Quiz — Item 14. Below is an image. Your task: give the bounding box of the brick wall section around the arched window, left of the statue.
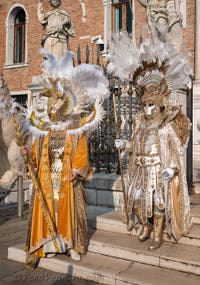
[0,0,42,91]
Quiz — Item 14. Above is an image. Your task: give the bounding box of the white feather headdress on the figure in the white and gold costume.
[107,33,192,101]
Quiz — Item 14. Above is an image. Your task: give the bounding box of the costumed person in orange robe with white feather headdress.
[21,49,109,268]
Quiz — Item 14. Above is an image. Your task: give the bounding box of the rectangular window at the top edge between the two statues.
[112,0,132,34]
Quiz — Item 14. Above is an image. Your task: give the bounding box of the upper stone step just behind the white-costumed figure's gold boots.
[92,206,200,247]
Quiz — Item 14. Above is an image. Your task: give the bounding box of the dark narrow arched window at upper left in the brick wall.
[14,9,26,63]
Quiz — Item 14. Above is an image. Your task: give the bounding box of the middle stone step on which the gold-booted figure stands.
[89,230,200,280]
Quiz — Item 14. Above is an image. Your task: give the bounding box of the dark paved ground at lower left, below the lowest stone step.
[0,207,100,285]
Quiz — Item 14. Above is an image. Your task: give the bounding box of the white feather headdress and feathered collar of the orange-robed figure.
[24,49,109,136]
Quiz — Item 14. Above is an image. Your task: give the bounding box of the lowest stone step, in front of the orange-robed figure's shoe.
[8,242,200,285]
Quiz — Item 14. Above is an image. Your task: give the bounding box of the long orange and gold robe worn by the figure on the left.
[24,130,91,262]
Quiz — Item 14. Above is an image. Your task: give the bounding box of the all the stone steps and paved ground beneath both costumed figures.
[0,195,200,285]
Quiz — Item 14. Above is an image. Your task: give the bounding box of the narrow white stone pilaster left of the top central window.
[103,0,112,51]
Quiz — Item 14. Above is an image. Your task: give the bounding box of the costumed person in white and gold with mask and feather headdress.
[108,35,191,250]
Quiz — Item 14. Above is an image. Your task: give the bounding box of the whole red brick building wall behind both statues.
[0,0,195,91]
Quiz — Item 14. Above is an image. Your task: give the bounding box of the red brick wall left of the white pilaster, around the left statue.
[0,0,103,91]
